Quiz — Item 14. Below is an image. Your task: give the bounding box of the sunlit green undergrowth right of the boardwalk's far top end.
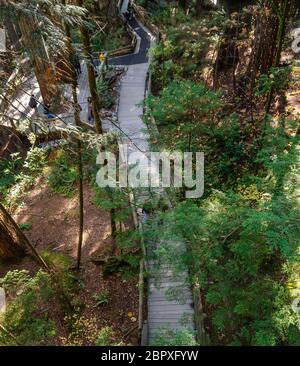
[151,5,223,94]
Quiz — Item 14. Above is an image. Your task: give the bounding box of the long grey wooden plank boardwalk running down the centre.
[113,6,195,345]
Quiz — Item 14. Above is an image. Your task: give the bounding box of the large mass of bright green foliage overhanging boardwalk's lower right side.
[148,129,300,346]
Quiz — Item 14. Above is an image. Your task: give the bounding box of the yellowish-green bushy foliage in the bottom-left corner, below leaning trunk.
[0,270,56,345]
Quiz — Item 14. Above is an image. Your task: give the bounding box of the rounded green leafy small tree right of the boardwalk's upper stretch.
[147,81,222,151]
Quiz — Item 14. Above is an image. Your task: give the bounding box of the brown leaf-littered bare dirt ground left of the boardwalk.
[0,178,138,345]
